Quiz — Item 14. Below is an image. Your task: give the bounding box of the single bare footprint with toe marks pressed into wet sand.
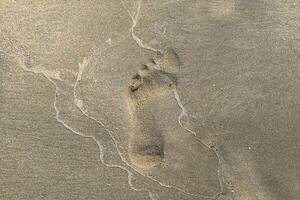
[127,49,180,170]
